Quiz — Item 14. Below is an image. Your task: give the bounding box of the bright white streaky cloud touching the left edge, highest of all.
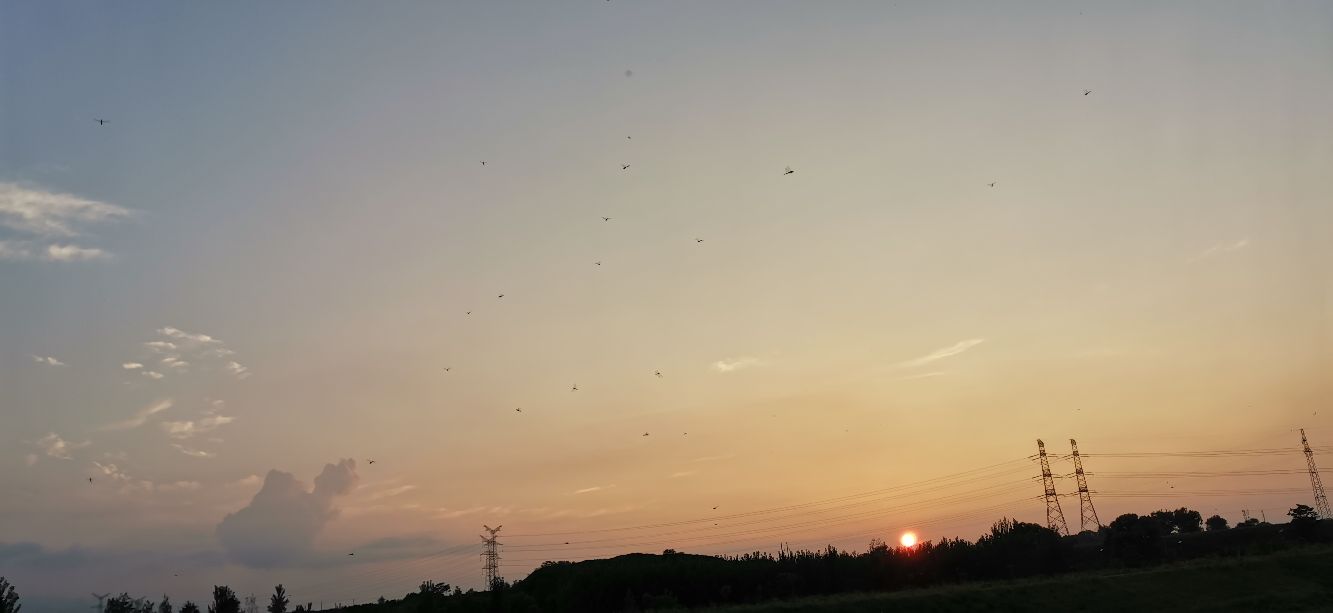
[0,183,129,261]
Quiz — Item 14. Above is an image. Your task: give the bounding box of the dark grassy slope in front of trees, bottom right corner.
[708,546,1333,613]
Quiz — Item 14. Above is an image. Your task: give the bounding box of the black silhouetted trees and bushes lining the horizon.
[10,505,1333,613]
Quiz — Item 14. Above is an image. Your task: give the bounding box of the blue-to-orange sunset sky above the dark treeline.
[0,0,1333,610]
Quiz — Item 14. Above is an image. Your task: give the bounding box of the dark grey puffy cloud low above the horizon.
[217,460,357,568]
